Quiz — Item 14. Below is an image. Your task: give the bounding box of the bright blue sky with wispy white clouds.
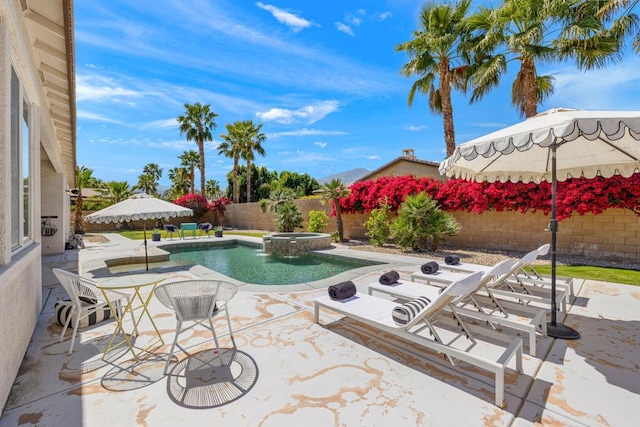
[75,0,640,188]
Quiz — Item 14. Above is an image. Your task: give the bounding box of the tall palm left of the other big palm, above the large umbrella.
[396,0,471,156]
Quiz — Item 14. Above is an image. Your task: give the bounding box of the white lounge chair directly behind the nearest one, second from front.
[368,259,548,356]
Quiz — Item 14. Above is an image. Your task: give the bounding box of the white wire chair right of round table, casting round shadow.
[154,280,238,375]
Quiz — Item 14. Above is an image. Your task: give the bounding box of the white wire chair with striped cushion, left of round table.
[51,268,136,354]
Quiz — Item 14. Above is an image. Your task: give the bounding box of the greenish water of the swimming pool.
[167,244,378,285]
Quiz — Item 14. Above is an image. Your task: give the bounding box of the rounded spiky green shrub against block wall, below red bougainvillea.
[391,193,460,251]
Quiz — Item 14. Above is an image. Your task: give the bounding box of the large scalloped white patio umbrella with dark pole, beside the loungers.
[439,108,640,339]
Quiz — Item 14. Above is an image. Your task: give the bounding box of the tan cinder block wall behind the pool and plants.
[85,199,640,262]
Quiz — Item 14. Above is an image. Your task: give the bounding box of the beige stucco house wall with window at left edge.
[0,0,68,411]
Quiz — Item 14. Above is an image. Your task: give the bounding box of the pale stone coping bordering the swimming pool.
[81,235,419,292]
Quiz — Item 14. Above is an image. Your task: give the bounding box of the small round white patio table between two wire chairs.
[98,273,165,360]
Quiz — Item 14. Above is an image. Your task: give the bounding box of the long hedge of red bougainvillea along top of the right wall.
[340,173,640,220]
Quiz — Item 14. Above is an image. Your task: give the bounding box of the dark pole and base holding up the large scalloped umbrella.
[547,144,580,340]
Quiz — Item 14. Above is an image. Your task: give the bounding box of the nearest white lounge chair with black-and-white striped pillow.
[314,272,522,407]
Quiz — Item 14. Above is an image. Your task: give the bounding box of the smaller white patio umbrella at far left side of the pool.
[84,193,193,270]
